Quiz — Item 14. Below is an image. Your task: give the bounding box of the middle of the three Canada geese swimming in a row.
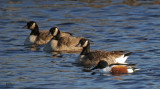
[43,27,83,52]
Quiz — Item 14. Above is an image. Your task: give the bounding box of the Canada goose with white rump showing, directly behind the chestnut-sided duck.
[76,38,131,67]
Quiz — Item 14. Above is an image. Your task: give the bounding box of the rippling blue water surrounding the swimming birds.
[0,0,160,89]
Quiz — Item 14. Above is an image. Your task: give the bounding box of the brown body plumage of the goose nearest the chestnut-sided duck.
[82,51,124,67]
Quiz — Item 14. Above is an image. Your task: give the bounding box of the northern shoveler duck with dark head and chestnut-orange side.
[91,60,140,75]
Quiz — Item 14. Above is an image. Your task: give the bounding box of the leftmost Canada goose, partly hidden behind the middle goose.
[23,21,71,45]
